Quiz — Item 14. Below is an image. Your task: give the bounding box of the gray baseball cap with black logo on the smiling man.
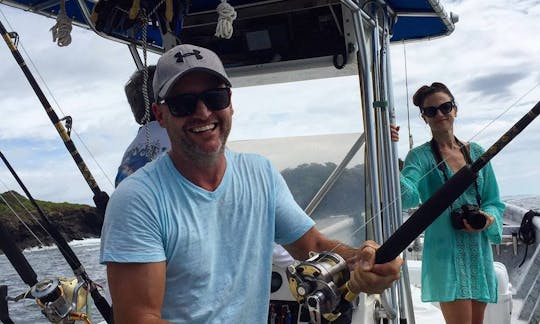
[152,44,231,101]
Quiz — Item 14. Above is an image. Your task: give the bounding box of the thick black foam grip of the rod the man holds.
[375,165,478,264]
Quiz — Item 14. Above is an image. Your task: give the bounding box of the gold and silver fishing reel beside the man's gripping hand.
[286,252,357,323]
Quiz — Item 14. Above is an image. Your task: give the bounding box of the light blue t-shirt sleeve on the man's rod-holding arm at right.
[272,168,315,245]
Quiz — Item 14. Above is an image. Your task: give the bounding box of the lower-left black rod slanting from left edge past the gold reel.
[0,151,113,323]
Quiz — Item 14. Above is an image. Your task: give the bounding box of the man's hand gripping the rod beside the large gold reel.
[349,241,403,294]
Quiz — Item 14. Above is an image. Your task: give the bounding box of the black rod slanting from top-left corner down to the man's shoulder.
[0,20,109,214]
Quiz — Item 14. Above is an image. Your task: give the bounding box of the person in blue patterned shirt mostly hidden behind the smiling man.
[114,65,171,187]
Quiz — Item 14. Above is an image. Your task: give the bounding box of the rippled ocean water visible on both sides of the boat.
[0,196,540,324]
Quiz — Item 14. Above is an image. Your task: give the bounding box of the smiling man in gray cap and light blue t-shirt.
[101,44,402,324]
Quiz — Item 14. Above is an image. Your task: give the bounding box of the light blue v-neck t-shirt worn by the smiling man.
[101,150,314,323]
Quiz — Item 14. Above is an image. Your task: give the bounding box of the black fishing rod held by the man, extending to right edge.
[375,101,540,264]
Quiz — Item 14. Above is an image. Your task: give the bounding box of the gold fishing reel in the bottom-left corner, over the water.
[30,278,90,324]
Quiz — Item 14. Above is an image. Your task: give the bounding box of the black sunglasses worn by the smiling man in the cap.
[159,88,231,117]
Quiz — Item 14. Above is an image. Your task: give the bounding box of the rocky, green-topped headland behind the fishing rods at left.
[0,191,103,253]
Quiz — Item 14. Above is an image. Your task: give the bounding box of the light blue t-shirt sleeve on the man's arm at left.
[100,177,166,263]
